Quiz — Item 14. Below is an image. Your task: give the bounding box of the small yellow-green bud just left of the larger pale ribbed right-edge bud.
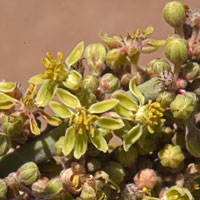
[156,91,175,108]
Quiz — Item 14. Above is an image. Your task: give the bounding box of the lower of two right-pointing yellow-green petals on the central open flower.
[97,117,124,130]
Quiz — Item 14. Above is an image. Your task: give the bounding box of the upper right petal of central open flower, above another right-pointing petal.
[89,99,119,113]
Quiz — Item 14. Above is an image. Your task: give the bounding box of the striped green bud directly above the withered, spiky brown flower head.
[147,58,171,76]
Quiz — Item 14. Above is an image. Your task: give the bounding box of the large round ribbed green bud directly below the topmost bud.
[165,37,189,64]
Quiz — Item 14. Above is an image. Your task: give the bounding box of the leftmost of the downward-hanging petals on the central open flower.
[62,127,76,156]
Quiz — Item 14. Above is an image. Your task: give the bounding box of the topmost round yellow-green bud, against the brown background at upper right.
[163,1,185,27]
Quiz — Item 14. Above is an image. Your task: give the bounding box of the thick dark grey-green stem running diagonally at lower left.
[0,122,68,178]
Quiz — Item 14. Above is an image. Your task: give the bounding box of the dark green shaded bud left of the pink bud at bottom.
[103,161,125,184]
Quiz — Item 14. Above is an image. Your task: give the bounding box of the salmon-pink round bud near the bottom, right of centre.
[134,169,158,190]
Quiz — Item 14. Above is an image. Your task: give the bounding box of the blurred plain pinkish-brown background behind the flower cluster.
[0,0,200,87]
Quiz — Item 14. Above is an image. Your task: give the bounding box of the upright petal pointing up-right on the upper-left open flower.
[65,42,84,69]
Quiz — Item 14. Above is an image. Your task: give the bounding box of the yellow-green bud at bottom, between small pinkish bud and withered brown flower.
[44,178,63,194]
